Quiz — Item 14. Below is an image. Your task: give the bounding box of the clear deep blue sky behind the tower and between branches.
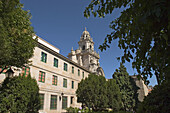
[21,0,156,85]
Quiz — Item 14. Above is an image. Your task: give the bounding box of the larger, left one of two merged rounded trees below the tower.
[76,74,108,111]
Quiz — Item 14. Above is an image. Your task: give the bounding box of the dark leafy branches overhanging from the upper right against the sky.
[84,0,170,84]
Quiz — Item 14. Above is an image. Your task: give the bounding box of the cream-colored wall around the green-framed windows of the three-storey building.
[30,47,89,113]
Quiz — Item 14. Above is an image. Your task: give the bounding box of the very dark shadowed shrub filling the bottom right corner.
[137,80,170,113]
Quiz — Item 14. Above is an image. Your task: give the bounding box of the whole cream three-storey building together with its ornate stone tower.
[0,29,105,113]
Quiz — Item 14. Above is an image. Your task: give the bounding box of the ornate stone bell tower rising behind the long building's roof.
[68,28,105,76]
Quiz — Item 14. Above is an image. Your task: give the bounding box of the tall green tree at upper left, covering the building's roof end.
[0,0,36,73]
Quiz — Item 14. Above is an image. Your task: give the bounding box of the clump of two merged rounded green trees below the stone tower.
[76,74,121,111]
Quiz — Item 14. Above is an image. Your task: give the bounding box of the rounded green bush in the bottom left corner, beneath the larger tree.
[0,75,40,113]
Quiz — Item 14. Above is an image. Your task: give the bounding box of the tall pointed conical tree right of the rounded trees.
[113,63,138,111]
